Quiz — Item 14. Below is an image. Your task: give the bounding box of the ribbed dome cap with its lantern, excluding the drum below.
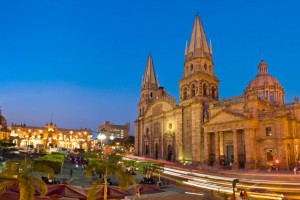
[246,60,282,92]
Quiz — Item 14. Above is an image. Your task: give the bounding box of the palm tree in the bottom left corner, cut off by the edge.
[0,158,54,200]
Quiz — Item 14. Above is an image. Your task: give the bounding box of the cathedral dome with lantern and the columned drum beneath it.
[245,60,284,104]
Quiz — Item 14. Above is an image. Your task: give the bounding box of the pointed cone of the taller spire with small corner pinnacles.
[185,15,212,58]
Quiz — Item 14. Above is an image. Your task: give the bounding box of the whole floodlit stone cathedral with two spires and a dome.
[135,16,300,169]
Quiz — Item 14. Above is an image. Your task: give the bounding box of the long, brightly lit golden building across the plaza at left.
[10,122,92,150]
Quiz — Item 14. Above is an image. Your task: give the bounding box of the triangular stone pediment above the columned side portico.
[203,110,249,126]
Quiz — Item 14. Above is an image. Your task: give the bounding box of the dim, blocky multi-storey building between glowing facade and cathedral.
[98,121,130,139]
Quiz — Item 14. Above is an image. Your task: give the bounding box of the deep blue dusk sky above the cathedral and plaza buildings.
[0,0,300,133]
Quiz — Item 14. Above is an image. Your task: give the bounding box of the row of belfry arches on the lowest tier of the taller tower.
[181,83,218,100]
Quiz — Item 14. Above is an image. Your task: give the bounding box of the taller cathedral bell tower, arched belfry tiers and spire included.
[179,15,220,105]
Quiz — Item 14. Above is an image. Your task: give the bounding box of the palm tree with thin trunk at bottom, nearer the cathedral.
[87,153,135,200]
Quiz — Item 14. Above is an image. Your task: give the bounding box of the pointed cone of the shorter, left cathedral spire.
[142,54,158,89]
